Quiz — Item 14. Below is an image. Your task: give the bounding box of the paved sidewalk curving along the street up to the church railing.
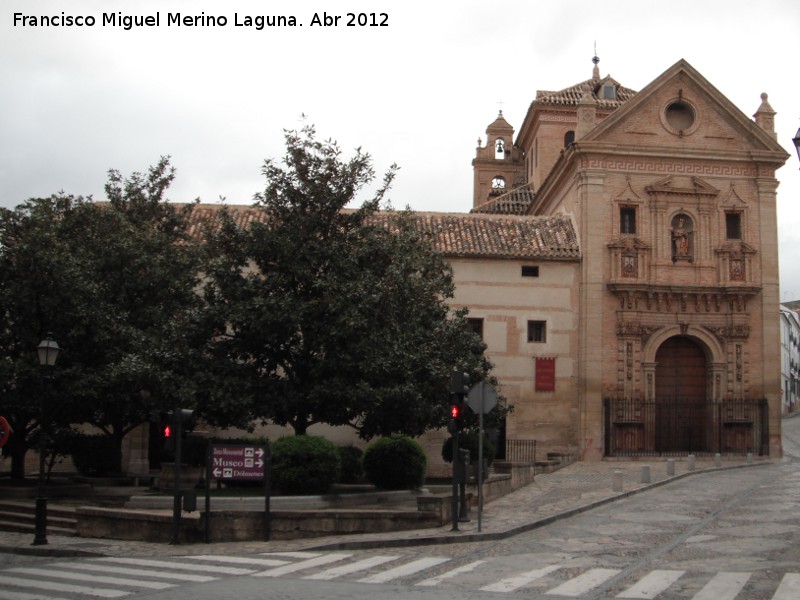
[0,458,772,557]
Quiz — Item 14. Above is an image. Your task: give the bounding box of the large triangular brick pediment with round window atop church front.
[581,60,788,160]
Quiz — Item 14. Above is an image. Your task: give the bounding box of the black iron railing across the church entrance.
[603,398,769,457]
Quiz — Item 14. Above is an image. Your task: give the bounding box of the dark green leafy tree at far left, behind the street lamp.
[0,158,201,478]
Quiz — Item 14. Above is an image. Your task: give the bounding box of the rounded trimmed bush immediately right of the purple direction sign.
[272,435,341,494]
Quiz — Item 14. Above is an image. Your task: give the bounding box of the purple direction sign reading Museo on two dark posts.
[205,444,271,543]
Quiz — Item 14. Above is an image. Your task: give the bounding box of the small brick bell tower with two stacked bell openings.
[472,110,524,208]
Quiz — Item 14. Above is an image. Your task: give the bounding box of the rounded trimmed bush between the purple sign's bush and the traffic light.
[362,437,428,490]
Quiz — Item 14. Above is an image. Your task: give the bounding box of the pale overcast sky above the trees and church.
[0,0,800,301]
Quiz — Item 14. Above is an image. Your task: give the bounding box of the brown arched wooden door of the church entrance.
[655,336,711,453]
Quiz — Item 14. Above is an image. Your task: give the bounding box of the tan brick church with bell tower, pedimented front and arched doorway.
[468,58,788,460]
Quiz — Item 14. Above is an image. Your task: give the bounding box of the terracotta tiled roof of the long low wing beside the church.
[182,204,580,260]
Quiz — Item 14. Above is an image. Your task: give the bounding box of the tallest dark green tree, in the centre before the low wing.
[197,127,490,439]
